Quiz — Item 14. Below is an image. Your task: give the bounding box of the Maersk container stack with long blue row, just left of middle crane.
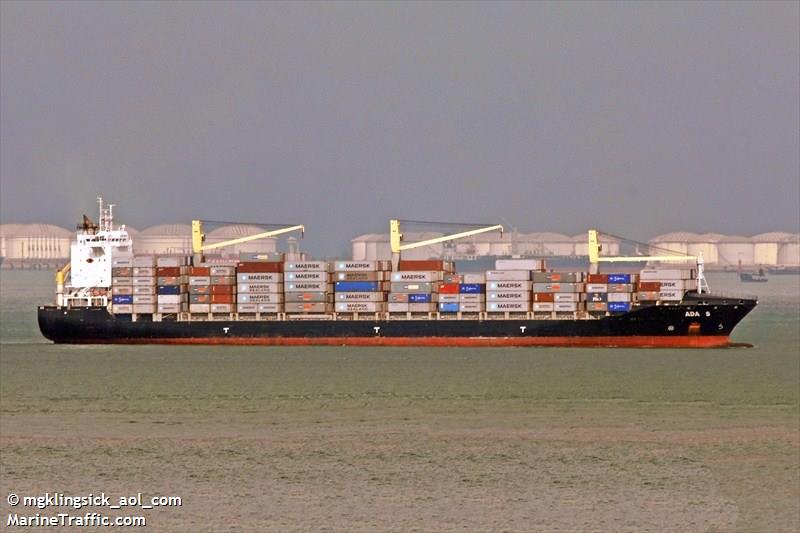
[333,261,391,316]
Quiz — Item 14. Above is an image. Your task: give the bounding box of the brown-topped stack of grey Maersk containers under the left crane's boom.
[236,261,284,316]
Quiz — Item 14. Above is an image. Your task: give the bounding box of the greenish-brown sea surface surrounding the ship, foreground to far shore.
[0,271,800,531]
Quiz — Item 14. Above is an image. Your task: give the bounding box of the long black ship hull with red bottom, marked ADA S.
[38,294,757,347]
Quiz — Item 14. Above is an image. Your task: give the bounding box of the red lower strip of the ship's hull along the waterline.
[67,335,731,348]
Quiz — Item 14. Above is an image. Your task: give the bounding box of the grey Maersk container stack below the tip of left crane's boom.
[283,261,333,314]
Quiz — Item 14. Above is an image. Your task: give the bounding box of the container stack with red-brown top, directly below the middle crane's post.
[387,260,450,313]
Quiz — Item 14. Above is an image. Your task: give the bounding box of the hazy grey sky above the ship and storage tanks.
[0,1,800,254]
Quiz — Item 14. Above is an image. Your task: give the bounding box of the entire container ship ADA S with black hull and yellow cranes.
[38,199,757,347]
